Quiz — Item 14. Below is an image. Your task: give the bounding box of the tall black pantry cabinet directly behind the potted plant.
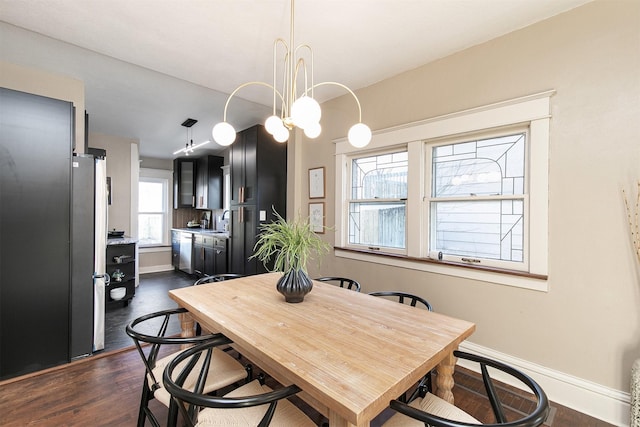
[229,125,287,275]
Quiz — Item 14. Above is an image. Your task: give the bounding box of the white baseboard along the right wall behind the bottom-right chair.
[458,341,631,427]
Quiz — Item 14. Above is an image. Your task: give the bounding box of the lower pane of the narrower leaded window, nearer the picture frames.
[349,202,405,249]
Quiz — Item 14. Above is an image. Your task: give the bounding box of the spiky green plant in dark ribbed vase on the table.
[251,209,330,303]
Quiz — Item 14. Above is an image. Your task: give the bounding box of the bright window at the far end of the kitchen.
[138,169,171,246]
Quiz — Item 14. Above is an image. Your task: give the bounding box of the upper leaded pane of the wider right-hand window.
[432,133,525,197]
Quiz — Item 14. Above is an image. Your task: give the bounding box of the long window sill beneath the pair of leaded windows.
[334,247,549,292]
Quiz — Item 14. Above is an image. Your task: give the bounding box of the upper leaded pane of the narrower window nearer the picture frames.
[351,151,408,199]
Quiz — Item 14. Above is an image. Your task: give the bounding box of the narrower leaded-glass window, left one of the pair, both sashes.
[349,151,408,251]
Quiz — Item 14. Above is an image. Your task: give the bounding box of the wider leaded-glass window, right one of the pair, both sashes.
[425,129,527,270]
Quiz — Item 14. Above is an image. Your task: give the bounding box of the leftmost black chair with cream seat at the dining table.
[126,308,252,427]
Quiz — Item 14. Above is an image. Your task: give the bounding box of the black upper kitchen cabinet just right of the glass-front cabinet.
[195,156,224,209]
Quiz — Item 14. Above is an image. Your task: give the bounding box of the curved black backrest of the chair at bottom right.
[390,351,549,427]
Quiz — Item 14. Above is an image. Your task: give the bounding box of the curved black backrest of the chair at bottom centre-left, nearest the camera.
[162,335,300,426]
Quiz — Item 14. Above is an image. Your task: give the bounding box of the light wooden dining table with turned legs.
[169,273,475,427]
